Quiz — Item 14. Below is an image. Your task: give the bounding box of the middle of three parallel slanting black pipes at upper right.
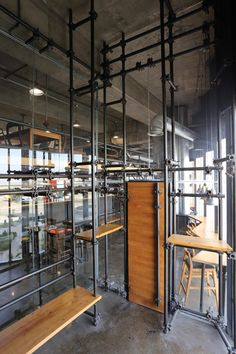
[106,22,214,66]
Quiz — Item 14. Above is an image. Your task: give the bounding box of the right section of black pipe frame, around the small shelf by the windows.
[160,0,236,354]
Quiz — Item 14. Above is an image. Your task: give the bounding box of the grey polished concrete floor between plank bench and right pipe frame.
[37,292,227,354]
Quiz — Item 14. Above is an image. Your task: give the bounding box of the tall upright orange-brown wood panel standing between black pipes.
[127,182,164,312]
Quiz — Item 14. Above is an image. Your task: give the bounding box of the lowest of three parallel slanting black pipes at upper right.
[109,42,214,79]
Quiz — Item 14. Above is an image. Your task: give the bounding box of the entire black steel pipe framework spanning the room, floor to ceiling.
[0,0,236,353]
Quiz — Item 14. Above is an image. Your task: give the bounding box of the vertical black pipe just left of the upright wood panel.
[121,32,128,294]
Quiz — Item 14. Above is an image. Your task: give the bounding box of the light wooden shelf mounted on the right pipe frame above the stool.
[168,234,233,253]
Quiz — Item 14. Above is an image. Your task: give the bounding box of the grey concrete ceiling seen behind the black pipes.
[0,0,213,137]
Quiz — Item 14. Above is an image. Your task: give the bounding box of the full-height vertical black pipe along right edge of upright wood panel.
[160,0,169,332]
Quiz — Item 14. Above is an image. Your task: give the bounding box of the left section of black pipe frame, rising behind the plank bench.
[0,0,98,324]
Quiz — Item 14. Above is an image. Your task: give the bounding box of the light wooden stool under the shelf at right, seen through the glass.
[179,248,218,306]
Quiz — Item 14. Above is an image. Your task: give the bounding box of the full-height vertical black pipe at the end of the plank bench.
[90,0,97,302]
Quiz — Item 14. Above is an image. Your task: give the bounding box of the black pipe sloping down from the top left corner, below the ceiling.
[0,5,90,70]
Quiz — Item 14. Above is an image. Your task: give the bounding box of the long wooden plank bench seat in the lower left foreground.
[0,287,101,354]
